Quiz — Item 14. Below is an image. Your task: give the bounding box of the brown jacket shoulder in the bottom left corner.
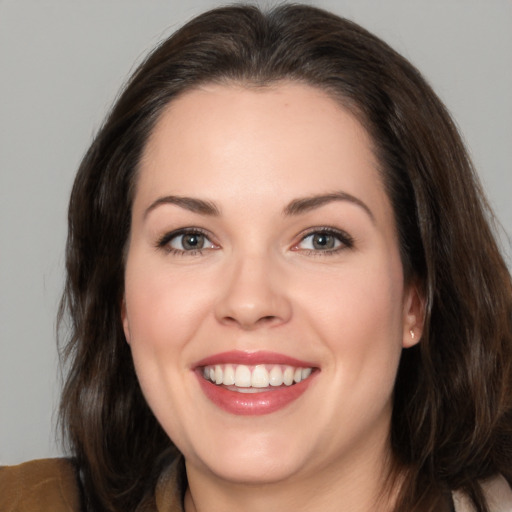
[0,459,79,512]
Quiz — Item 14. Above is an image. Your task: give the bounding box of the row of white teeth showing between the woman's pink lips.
[202,364,313,393]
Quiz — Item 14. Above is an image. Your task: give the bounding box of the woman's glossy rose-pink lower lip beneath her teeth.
[196,372,316,416]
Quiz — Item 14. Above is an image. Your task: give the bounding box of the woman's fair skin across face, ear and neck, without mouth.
[122,82,422,512]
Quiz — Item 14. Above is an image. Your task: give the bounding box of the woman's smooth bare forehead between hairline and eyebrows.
[136,82,385,220]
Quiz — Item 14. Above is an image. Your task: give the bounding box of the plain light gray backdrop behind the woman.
[0,0,512,464]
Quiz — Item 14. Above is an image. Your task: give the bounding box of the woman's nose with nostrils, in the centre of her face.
[215,256,292,331]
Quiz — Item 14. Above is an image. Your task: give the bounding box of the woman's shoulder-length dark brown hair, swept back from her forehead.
[60,5,512,512]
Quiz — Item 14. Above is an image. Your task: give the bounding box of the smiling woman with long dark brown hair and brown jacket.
[0,6,512,512]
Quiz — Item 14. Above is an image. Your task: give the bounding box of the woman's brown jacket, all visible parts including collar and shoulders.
[0,459,512,512]
